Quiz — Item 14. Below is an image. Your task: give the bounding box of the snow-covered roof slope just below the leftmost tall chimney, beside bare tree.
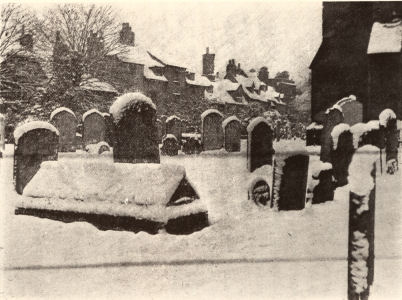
[109,44,163,67]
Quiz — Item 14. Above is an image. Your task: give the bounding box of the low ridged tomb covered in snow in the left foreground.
[16,161,208,234]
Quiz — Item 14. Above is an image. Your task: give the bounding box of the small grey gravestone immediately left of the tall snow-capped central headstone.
[82,109,106,147]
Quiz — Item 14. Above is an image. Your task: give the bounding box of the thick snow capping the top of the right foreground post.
[348,145,380,196]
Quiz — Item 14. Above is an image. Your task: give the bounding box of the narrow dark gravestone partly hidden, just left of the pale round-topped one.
[320,104,343,162]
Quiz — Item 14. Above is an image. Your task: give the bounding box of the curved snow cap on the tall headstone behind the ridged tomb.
[109,92,156,122]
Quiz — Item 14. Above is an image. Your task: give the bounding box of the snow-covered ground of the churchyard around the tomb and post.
[0,139,402,299]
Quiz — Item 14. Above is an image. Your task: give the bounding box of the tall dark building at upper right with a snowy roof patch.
[310,2,402,122]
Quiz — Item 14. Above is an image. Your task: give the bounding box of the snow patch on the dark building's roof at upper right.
[367,20,402,54]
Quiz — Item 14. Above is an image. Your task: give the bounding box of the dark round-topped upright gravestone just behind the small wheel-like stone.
[247,117,274,172]
